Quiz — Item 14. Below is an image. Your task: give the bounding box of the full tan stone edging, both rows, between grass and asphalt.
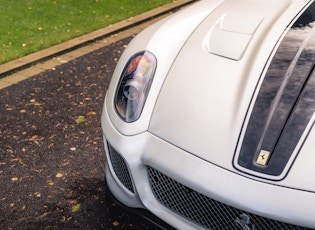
[0,0,195,90]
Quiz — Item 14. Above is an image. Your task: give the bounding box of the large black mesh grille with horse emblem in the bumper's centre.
[148,167,307,230]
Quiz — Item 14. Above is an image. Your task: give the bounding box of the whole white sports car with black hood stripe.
[102,0,315,230]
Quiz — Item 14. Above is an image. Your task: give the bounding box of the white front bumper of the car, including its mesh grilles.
[102,105,315,229]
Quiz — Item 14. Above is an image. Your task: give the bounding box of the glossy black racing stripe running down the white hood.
[237,0,315,179]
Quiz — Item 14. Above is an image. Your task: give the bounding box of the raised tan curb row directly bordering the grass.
[0,0,196,79]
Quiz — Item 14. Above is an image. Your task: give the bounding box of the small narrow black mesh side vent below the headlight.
[108,144,134,193]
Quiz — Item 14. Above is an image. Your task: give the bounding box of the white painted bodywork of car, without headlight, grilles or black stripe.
[102,0,315,229]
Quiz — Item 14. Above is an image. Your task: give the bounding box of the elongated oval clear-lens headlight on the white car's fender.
[114,51,157,122]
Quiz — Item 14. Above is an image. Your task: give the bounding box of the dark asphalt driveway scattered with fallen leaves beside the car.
[0,38,163,229]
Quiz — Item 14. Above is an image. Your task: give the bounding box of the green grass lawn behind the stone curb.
[0,0,172,64]
